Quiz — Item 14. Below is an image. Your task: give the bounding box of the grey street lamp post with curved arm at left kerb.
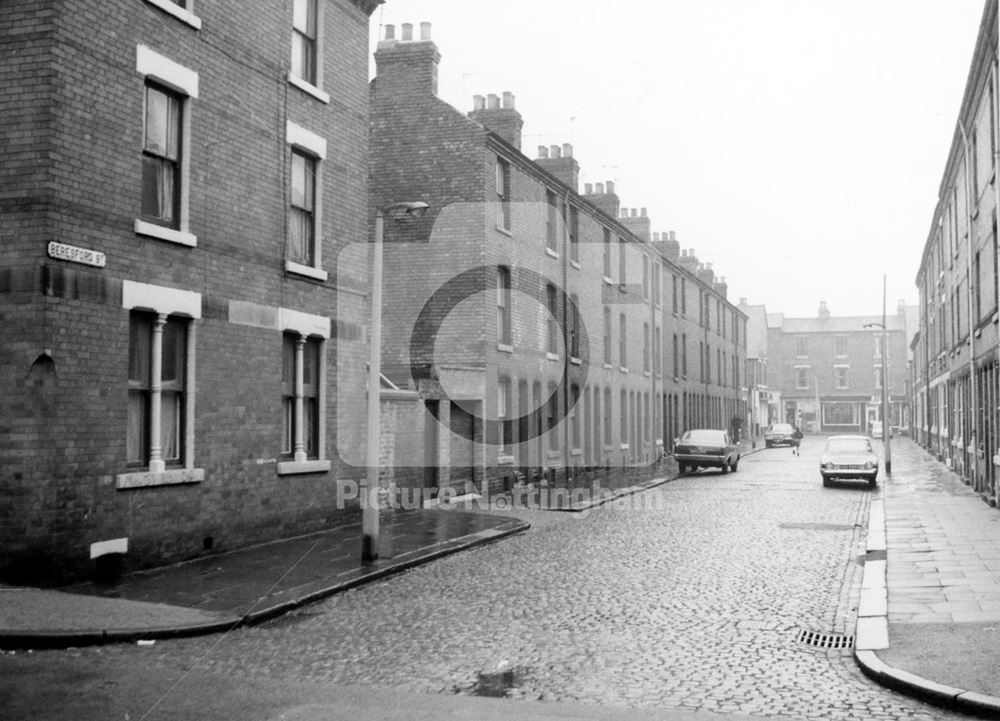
[361,201,428,561]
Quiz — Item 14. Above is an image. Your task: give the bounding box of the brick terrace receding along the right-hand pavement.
[912,0,1000,505]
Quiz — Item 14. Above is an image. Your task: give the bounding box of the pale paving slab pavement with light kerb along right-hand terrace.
[856,438,1000,718]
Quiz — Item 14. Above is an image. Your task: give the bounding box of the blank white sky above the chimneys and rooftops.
[371,0,983,316]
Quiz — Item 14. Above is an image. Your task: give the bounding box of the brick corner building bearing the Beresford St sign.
[0,0,377,581]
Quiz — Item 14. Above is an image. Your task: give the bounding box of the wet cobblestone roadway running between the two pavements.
[74,439,959,719]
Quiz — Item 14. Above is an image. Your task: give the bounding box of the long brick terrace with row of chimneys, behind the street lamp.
[371,23,746,492]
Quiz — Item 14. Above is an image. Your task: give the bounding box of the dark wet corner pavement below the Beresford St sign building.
[0,508,528,648]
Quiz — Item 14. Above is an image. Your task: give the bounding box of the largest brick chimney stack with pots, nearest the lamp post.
[375,22,441,100]
